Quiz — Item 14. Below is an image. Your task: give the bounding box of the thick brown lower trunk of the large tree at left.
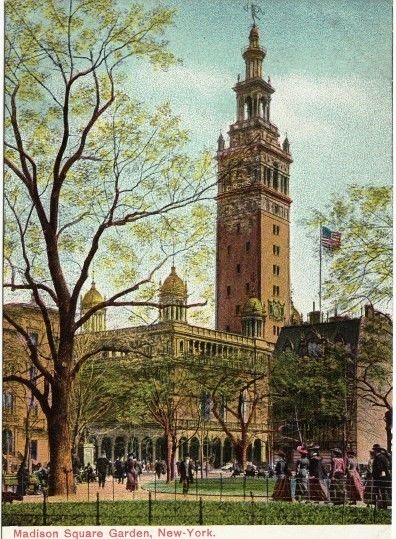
[47,374,75,495]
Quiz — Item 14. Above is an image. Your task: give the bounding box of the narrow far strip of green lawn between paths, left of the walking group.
[143,477,275,498]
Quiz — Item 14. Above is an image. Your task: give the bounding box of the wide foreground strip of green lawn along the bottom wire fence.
[2,500,391,526]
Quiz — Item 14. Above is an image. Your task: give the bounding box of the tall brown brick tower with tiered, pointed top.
[216,25,292,343]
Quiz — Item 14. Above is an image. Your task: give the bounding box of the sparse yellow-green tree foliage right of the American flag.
[307,185,392,309]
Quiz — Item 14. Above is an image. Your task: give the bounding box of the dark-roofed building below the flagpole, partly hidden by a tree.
[271,309,387,463]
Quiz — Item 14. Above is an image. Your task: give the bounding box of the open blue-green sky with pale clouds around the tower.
[130,0,392,320]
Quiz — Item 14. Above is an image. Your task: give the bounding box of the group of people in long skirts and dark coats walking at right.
[273,444,391,508]
